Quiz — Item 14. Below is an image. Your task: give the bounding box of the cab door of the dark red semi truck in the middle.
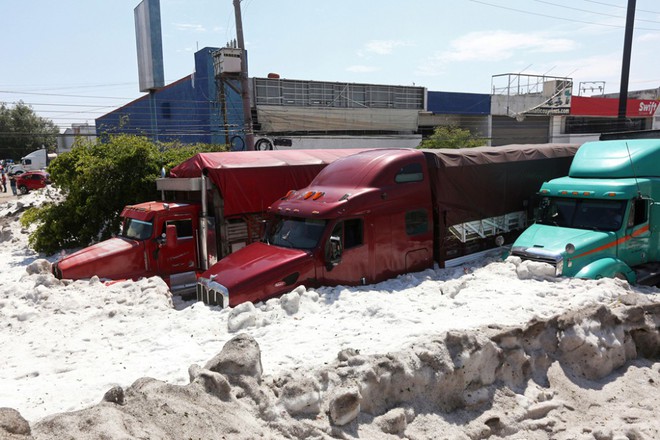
[321,218,373,286]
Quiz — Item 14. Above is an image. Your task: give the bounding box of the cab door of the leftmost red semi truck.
[156,217,197,278]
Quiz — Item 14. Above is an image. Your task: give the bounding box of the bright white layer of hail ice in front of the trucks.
[0,191,658,438]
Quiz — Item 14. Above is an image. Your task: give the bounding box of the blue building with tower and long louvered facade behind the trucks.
[96,47,491,150]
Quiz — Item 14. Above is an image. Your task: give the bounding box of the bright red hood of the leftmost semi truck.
[53,238,148,280]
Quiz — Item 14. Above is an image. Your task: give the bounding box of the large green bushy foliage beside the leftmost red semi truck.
[30,135,225,253]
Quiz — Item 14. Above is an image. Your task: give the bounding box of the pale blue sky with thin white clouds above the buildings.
[0,0,660,128]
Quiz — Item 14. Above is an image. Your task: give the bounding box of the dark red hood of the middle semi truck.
[200,243,316,306]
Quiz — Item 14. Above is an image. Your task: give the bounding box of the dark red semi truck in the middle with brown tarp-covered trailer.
[197,144,578,307]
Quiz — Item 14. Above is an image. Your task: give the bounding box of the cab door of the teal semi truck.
[619,198,651,267]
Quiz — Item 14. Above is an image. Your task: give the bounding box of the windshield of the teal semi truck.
[537,197,626,231]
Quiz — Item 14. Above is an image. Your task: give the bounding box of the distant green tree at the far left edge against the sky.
[0,101,59,161]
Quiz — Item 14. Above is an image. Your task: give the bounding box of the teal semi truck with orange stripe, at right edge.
[511,139,660,285]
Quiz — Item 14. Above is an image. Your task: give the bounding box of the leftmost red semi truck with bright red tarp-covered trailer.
[52,149,362,295]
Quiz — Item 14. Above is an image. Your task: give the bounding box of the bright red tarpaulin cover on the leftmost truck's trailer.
[170,149,364,217]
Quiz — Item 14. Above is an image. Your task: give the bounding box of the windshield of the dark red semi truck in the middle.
[265,217,326,249]
